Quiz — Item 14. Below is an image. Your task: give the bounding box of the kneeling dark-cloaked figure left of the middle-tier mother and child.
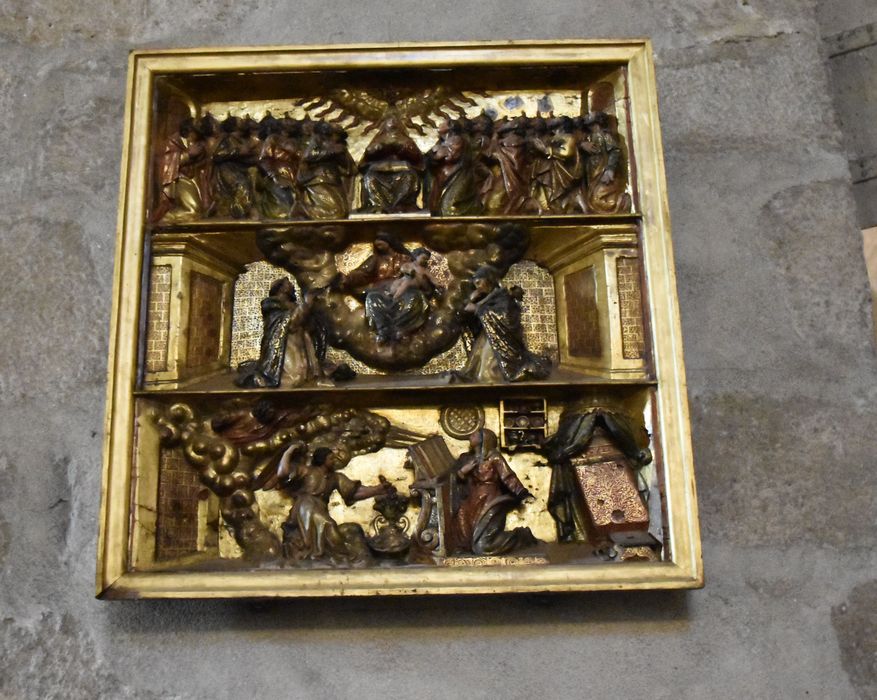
[235,277,323,388]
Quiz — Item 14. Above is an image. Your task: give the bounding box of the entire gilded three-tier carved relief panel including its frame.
[98,41,702,597]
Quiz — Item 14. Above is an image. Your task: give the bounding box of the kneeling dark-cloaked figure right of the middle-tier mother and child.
[451,265,551,382]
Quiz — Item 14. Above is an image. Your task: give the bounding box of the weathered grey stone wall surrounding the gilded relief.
[0,0,877,700]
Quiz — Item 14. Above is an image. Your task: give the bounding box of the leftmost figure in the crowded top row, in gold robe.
[151,119,207,223]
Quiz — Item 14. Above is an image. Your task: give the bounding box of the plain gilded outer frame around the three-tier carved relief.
[97,39,703,598]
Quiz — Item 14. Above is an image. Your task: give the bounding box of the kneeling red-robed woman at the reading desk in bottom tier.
[450,428,538,556]
